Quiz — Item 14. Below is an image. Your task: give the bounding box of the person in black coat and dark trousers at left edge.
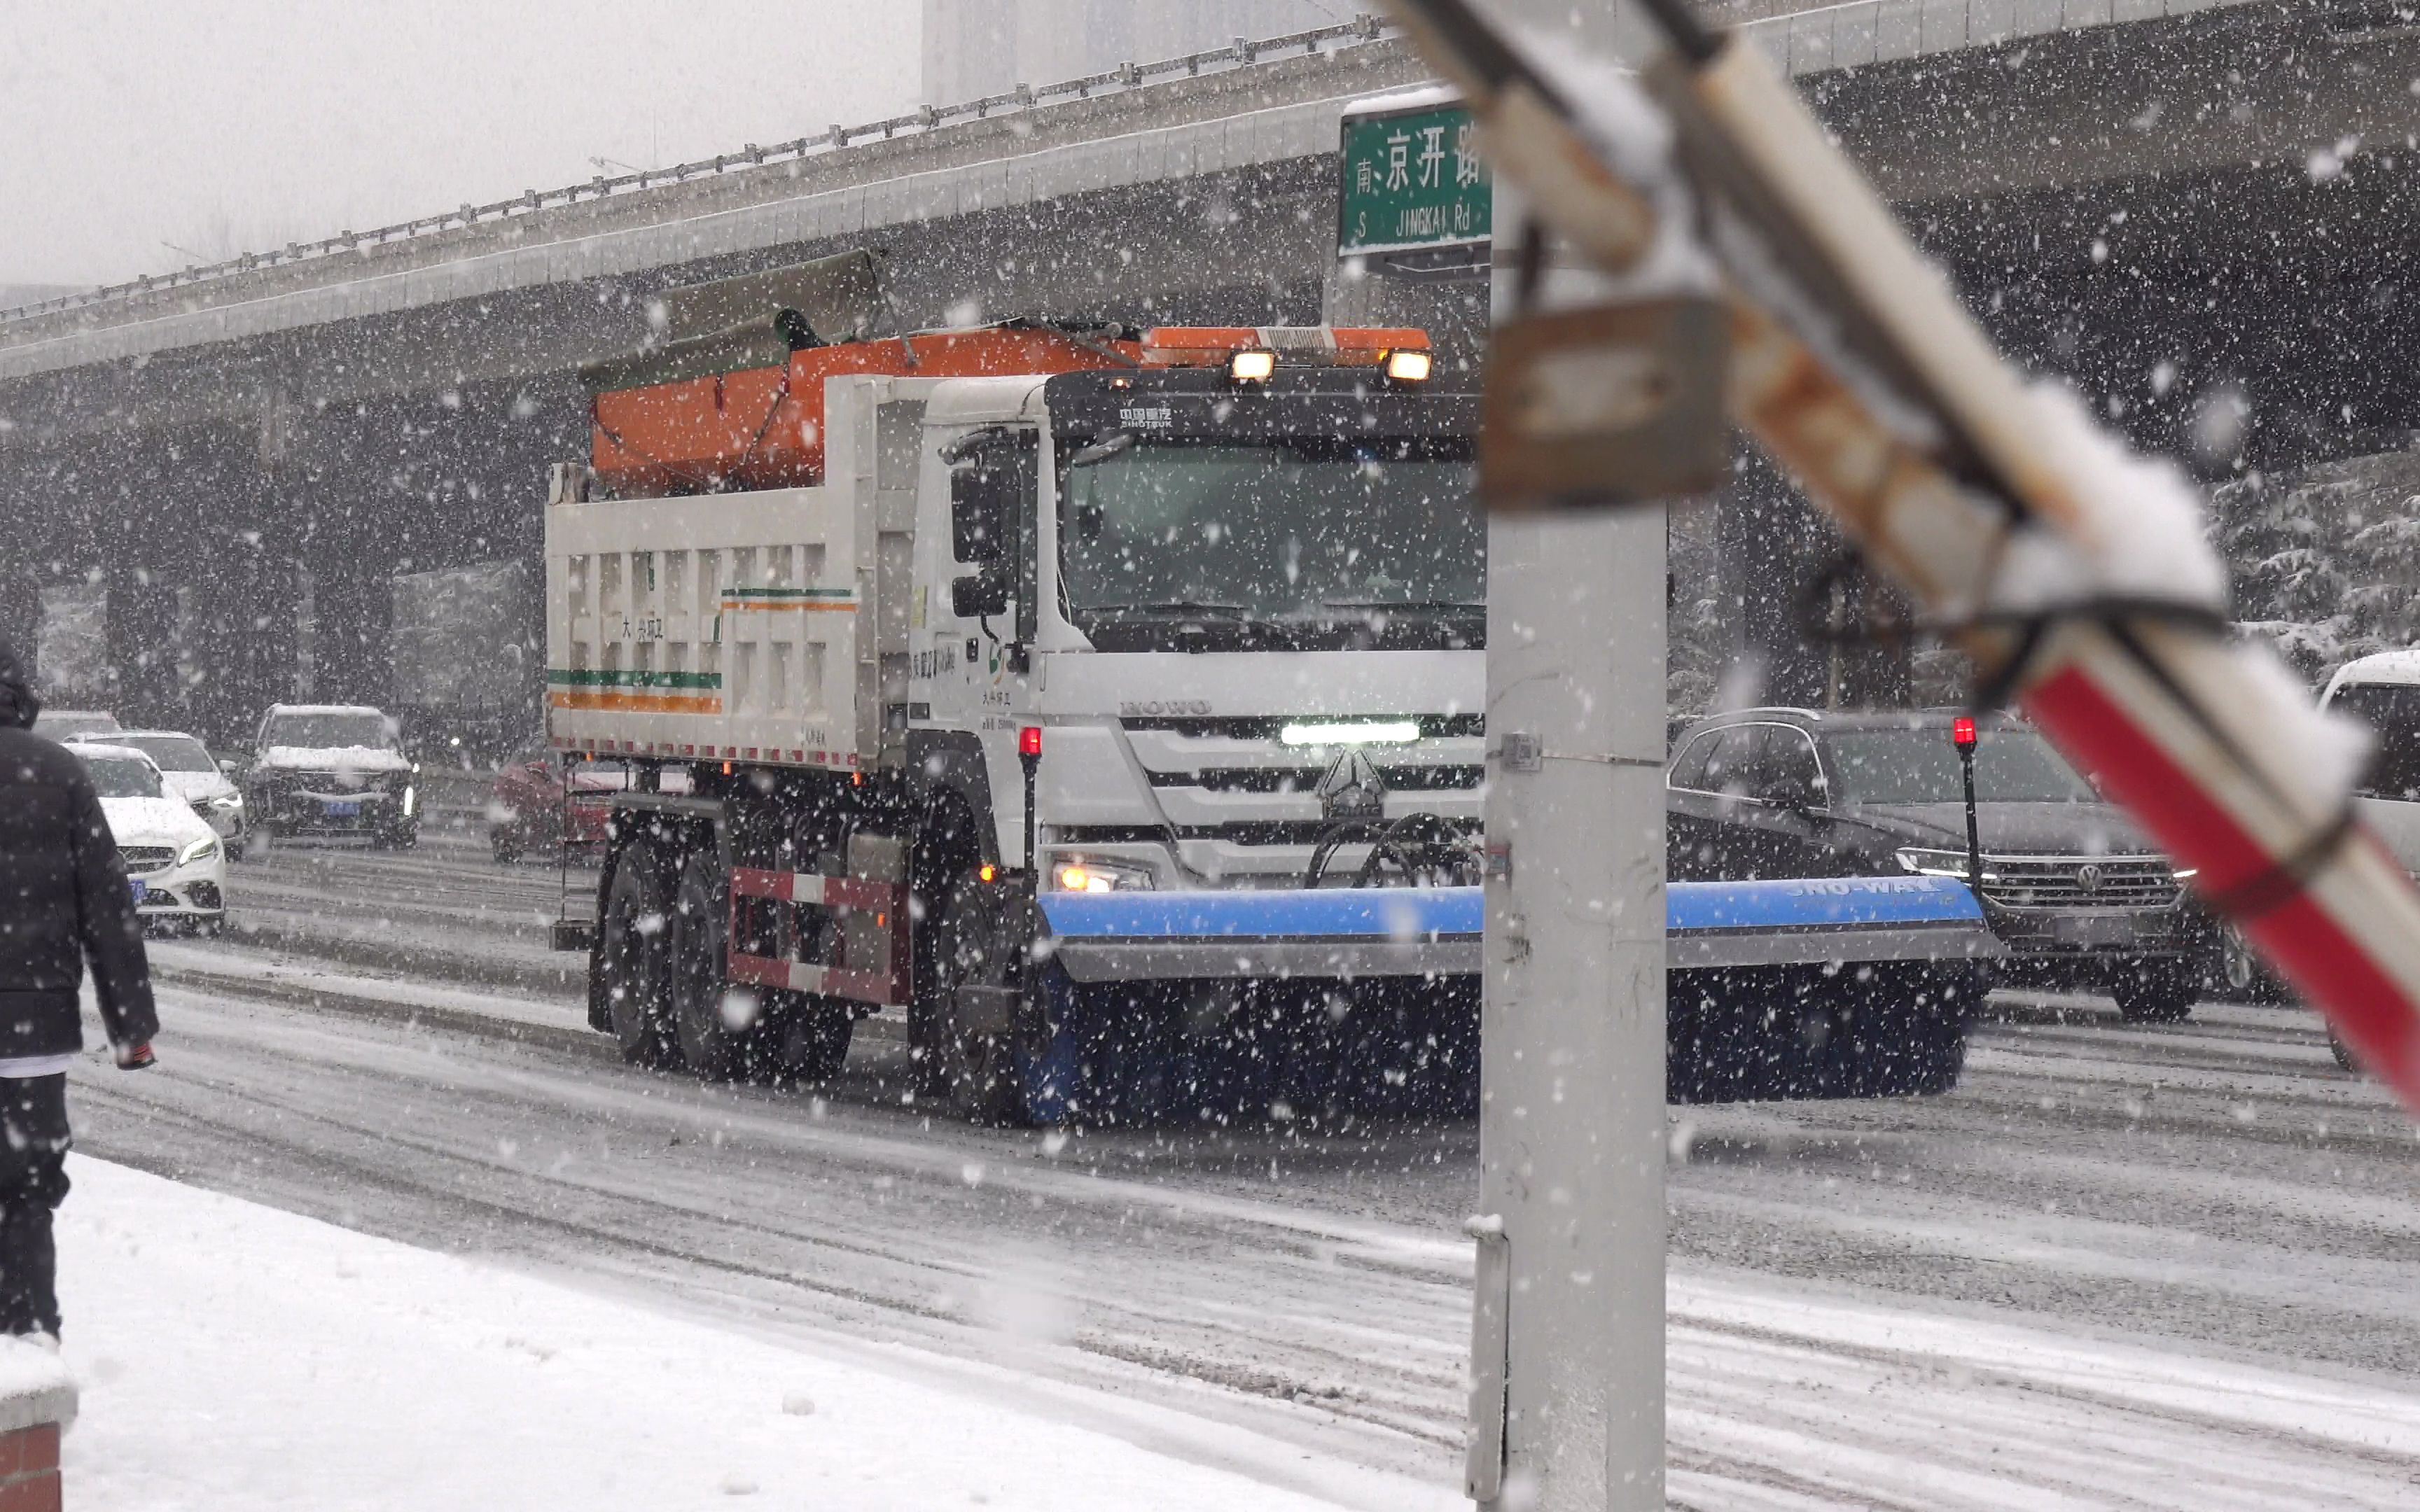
[0,641,160,1338]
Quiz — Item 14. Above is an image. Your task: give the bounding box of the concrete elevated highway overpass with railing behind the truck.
[0,0,2420,728]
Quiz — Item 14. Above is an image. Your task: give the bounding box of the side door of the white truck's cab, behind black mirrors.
[912,426,1041,856]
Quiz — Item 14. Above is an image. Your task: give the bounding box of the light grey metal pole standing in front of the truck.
[1466,164,1665,1512]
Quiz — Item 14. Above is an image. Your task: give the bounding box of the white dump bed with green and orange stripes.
[545,377,934,769]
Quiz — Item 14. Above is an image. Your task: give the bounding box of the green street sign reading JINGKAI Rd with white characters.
[1336,104,1496,256]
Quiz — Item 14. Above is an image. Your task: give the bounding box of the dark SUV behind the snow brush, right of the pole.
[1665,709,2202,1023]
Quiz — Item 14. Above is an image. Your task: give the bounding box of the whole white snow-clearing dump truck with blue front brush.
[545,256,1996,1123]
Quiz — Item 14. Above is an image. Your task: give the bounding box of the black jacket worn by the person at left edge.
[0,643,160,1057]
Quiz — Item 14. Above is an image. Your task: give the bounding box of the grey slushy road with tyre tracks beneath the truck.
[70,832,2420,1507]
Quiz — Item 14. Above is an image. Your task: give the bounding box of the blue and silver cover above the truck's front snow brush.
[1041,876,2001,982]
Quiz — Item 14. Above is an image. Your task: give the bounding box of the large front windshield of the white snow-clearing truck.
[1060,438,1486,641]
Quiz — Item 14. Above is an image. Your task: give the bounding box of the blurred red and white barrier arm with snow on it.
[1386,0,2420,1113]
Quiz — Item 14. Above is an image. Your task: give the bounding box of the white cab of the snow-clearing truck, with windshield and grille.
[908,348,1486,892]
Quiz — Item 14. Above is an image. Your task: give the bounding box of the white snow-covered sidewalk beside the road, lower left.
[58,1156,1461,1512]
